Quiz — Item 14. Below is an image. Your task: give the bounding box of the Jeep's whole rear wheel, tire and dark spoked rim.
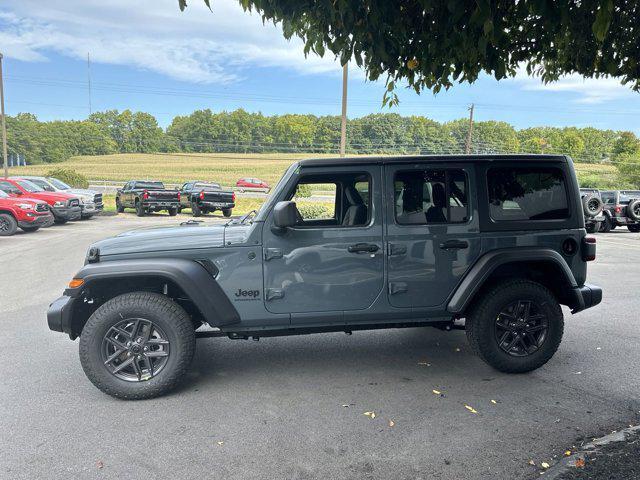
[465,280,564,373]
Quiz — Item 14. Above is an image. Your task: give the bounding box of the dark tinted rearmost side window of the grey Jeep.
[487,167,569,221]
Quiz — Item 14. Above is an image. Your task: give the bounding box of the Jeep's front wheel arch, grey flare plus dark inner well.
[63,259,240,338]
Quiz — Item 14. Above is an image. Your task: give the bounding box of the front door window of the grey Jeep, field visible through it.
[289,173,371,227]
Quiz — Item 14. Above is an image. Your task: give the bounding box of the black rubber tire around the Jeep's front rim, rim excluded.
[79,292,196,400]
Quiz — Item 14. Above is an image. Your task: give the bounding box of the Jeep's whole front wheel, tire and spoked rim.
[80,292,195,400]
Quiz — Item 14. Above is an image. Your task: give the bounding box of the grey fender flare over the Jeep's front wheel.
[70,258,240,327]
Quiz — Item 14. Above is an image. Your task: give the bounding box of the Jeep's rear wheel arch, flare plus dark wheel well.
[447,248,582,316]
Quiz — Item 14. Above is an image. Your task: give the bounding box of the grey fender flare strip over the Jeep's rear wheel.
[447,248,581,314]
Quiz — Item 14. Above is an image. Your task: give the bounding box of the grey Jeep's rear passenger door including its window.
[385,162,481,309]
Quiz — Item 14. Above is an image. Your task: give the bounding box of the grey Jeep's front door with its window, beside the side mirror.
[263,165,384,324]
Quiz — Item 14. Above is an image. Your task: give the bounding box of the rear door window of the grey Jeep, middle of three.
[393,169,469,225]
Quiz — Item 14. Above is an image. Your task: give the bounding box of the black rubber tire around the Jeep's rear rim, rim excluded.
[465,279,564,373]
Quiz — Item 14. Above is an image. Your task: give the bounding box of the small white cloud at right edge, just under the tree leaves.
[515,72,638,104]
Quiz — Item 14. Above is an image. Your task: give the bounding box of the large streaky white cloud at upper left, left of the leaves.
[0,0,340,83]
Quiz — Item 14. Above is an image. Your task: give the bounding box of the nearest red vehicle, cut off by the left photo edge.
[0,190,53,237]
